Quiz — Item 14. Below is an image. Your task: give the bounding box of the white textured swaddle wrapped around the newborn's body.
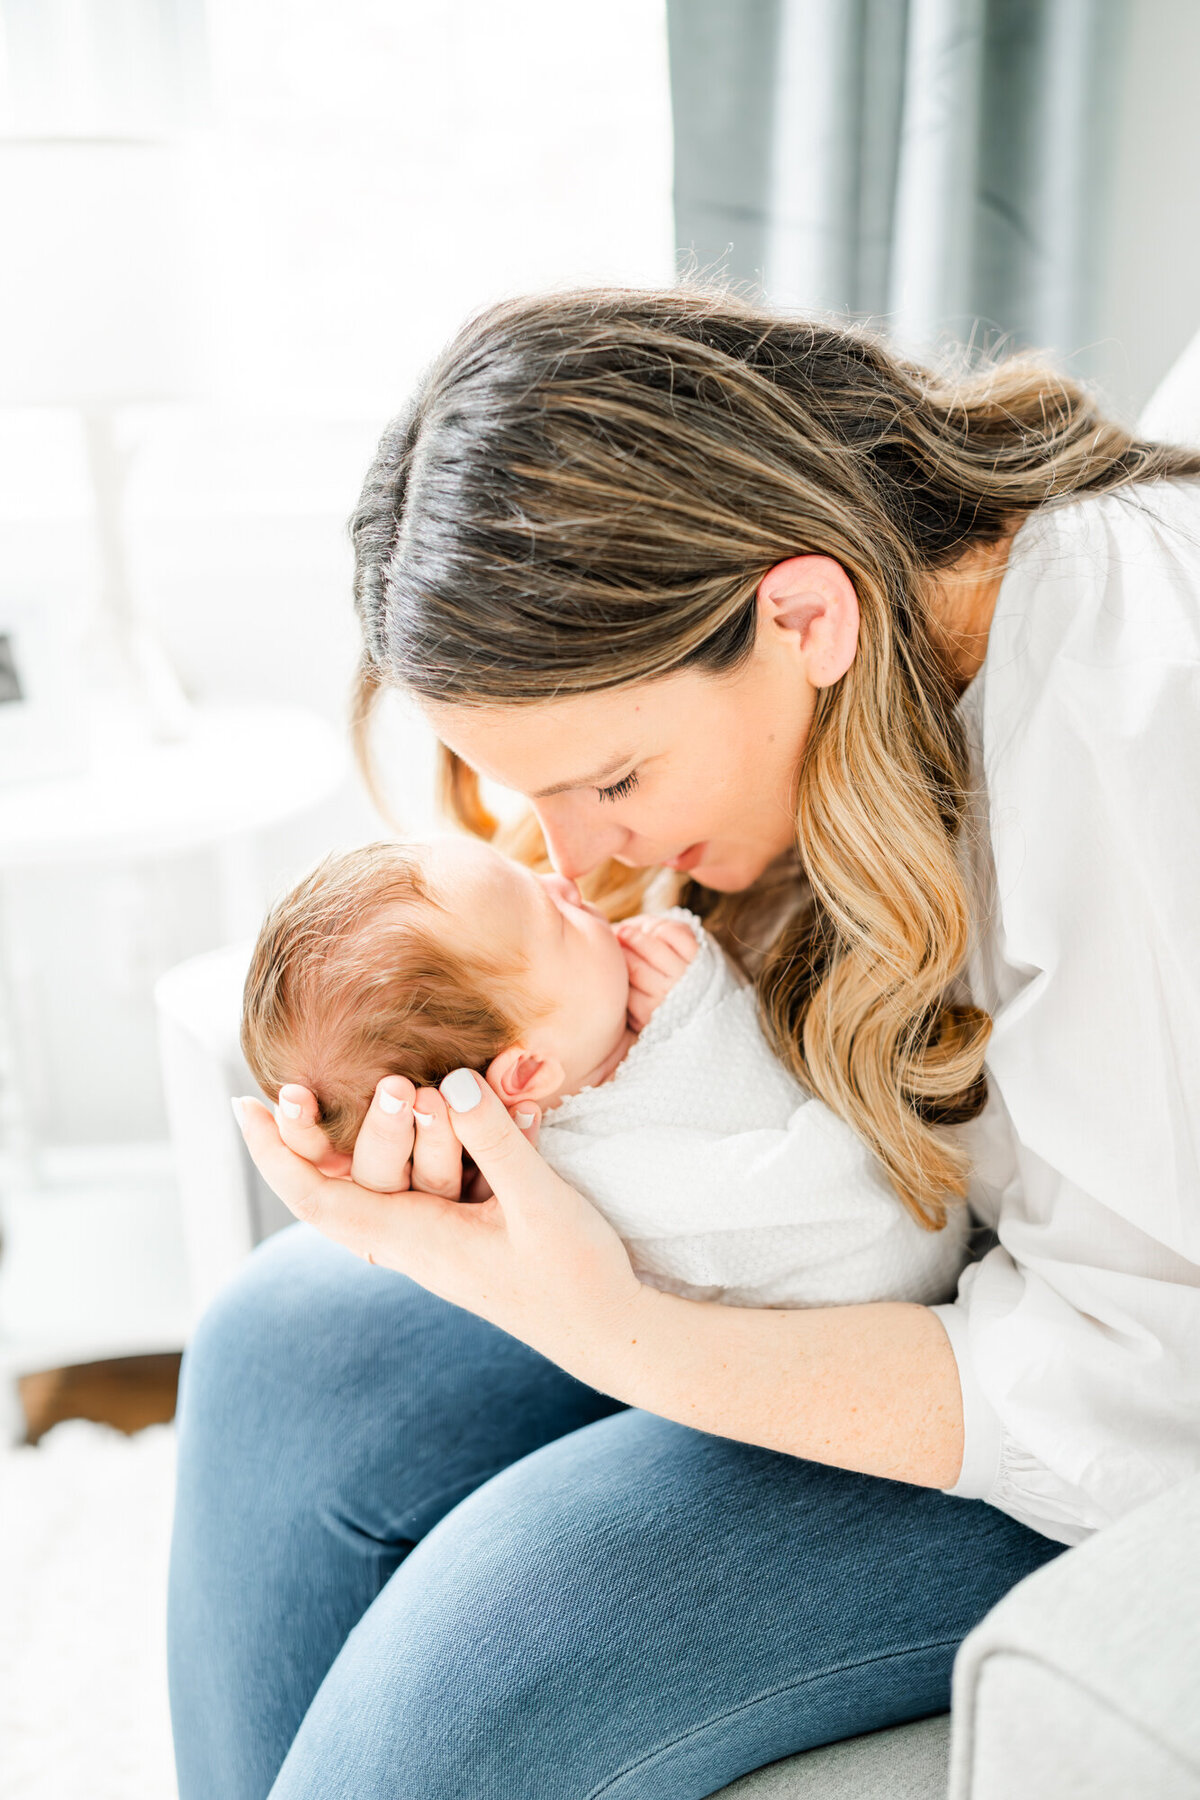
[538,907,966,1307]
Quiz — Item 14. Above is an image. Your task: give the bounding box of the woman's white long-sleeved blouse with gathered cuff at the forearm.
[934,481,1200,1544]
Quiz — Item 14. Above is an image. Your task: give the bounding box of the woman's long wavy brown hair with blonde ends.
[351,288,1200,1229]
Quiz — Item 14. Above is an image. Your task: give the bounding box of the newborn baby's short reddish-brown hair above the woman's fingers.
[241,842,520,1150]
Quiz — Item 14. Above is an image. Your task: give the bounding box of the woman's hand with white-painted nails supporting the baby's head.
[234,1069,642,1381]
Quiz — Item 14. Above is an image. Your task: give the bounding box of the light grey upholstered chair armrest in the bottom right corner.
[950,1478,1200,1800]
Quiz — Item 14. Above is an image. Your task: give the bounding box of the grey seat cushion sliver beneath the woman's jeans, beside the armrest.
[721,1712,950,1800]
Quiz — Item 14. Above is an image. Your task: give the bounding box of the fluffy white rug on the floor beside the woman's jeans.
[0,1420,176,1800]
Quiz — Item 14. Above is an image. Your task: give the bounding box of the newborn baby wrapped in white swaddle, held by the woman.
[243,837,966,1307]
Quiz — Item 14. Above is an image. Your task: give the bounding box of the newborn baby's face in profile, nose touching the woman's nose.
[421,837,630,1093]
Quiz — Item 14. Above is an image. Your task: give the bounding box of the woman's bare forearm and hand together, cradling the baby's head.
[237,1069,963,1487]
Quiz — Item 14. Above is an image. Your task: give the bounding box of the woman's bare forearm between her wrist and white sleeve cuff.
[585,1287,963,1487]
